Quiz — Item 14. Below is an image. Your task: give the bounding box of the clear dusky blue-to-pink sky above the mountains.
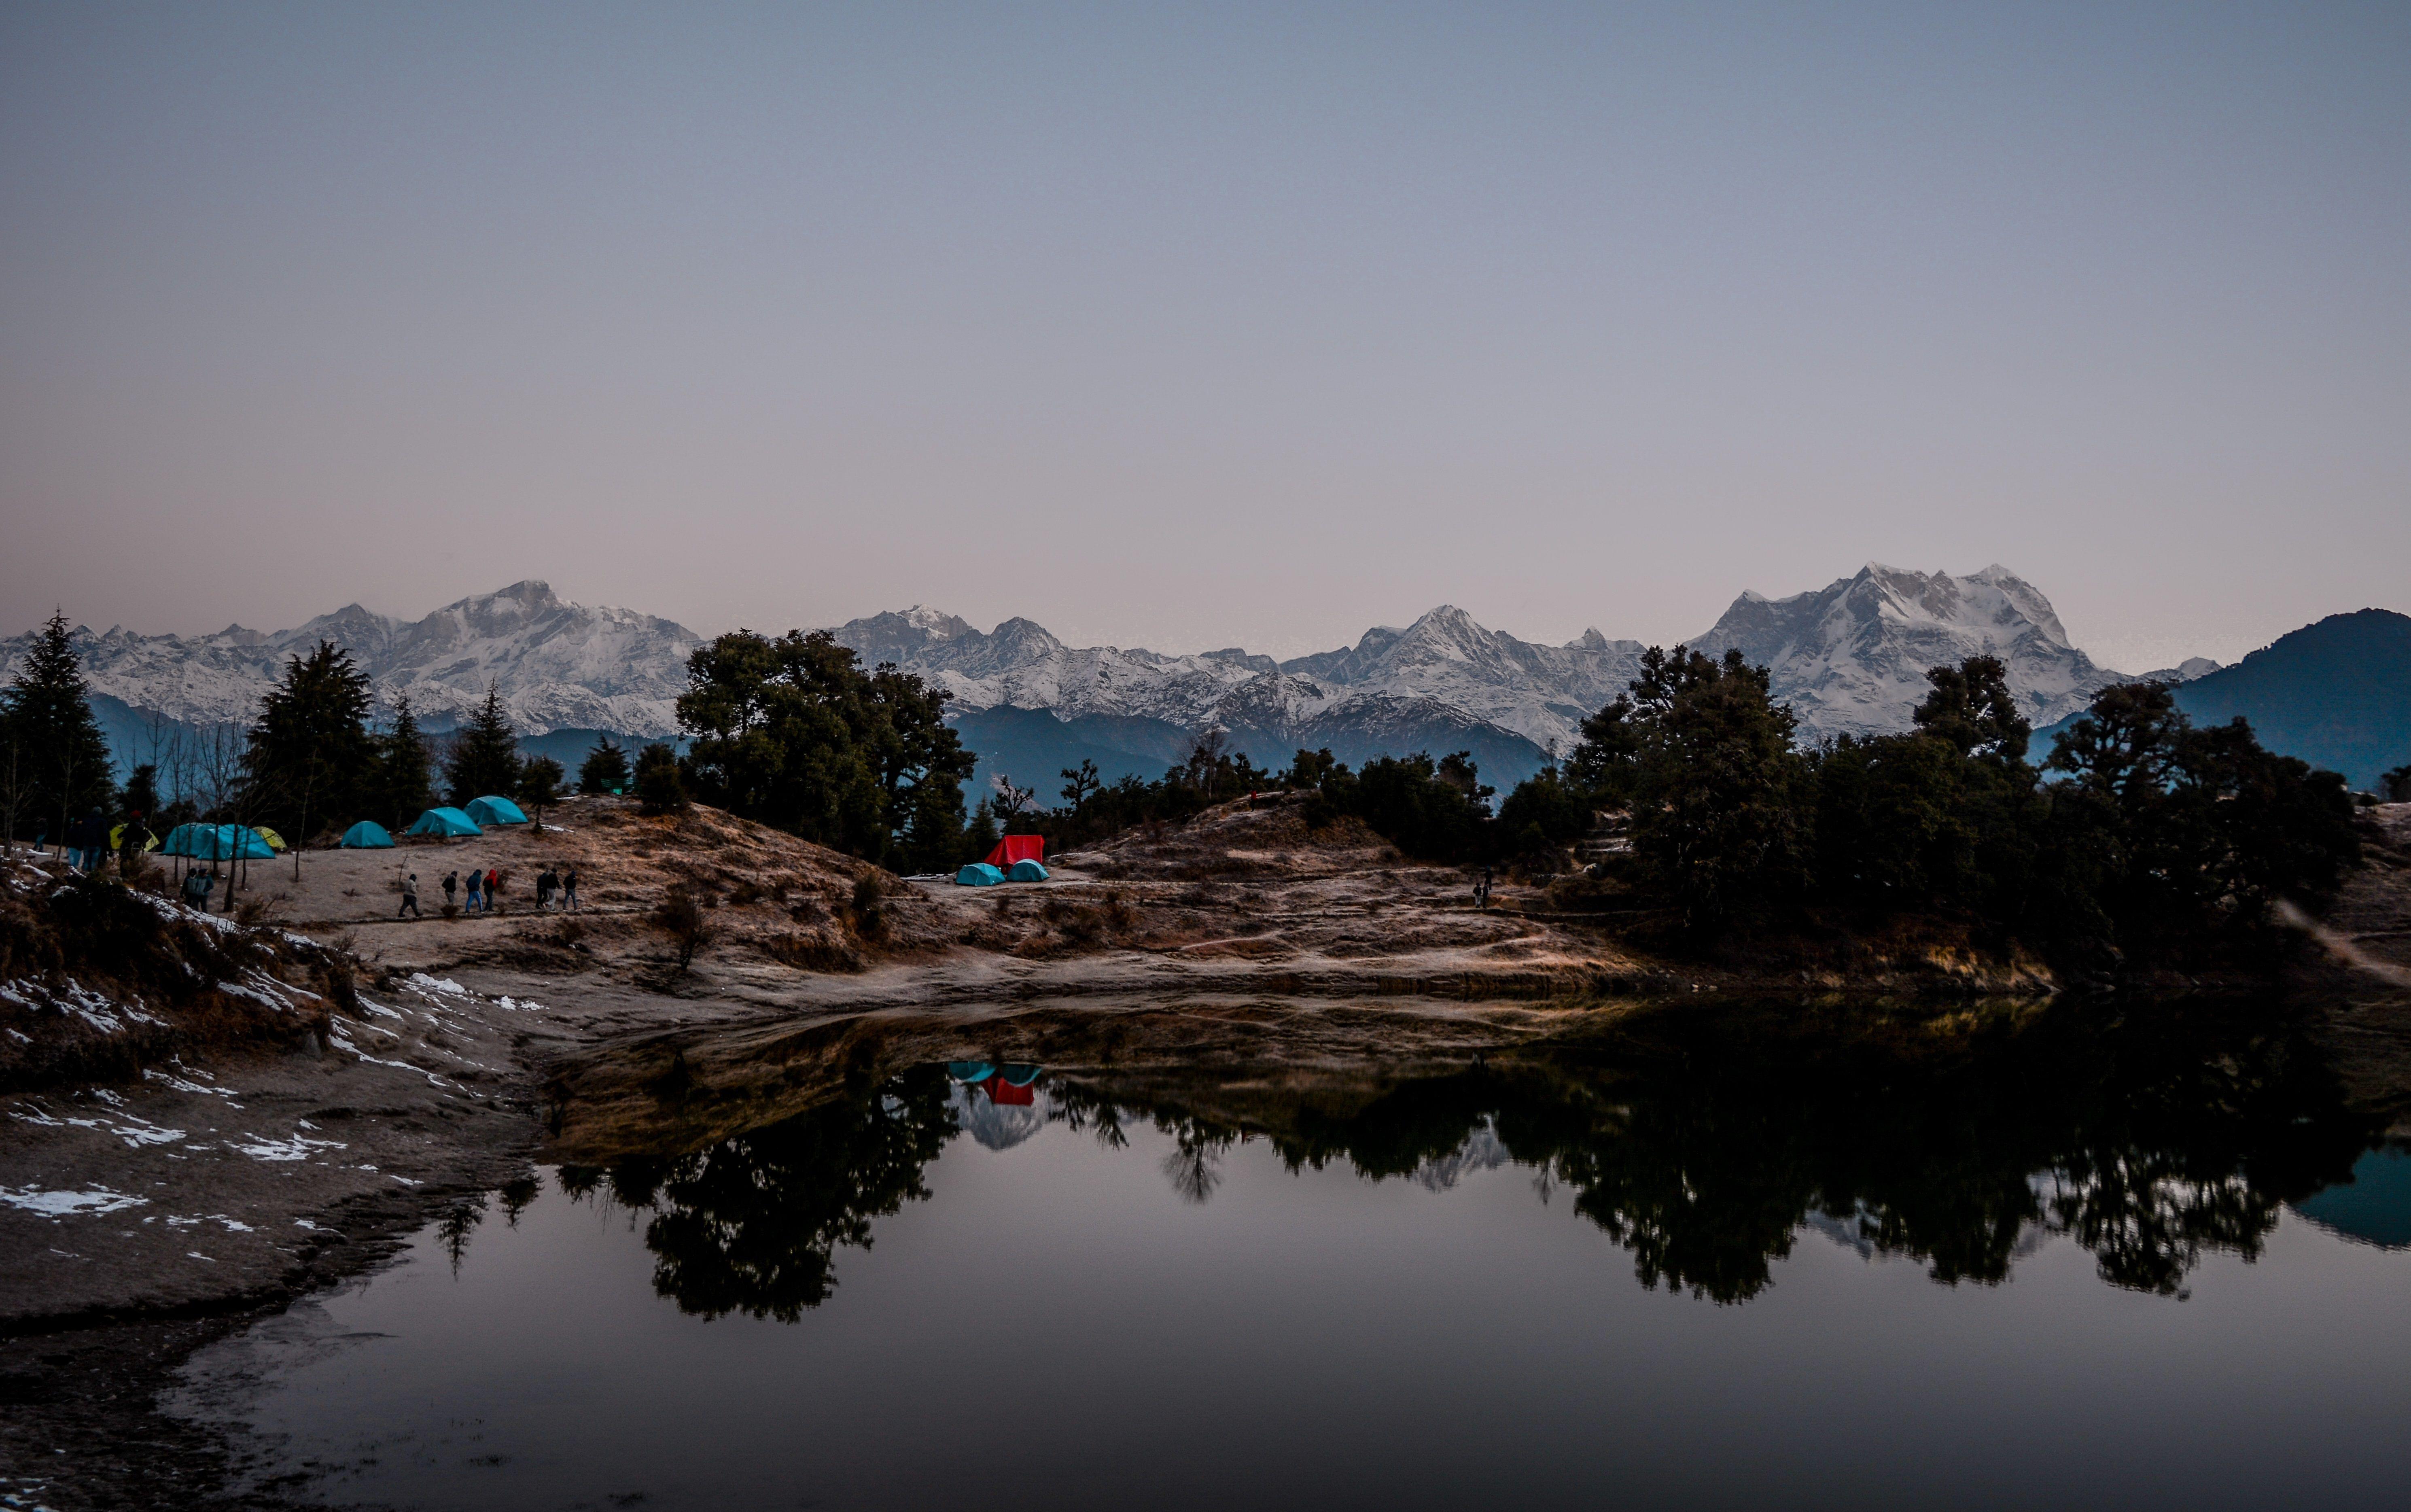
[0,0,2411,670]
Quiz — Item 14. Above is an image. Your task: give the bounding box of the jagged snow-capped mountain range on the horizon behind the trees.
[0,564,2170,776]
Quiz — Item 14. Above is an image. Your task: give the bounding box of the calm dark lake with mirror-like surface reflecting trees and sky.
[191,1022,2411,1512]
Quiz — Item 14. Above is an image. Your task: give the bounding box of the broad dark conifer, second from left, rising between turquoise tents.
[244,641,376,846]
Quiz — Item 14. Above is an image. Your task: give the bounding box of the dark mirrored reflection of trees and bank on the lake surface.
[562,1010,2404,1321]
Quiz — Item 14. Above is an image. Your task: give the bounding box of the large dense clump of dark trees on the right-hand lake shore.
[1499,646,2360,960]
